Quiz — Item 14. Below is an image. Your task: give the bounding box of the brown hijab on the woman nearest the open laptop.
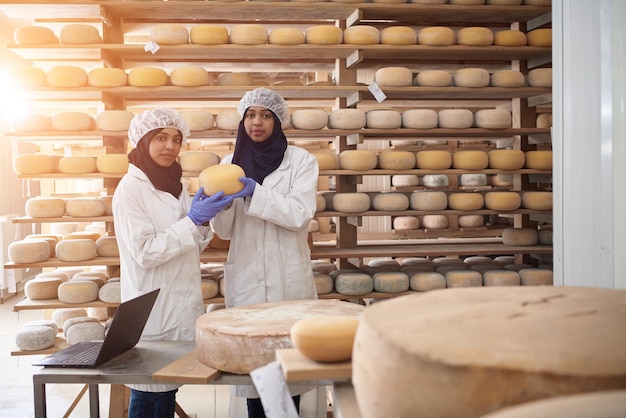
[128,129,183,199]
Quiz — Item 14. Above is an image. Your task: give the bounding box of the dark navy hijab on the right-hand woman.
[232,109,287,184]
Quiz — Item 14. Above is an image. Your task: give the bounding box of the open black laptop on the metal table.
[33,289,160,367]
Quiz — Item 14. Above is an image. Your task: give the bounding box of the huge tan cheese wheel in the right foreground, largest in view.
[352,286,626,418]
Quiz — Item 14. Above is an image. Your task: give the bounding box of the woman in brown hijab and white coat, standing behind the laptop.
[113,108,233,418]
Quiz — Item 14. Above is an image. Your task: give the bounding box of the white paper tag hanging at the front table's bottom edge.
[250,361,298,418]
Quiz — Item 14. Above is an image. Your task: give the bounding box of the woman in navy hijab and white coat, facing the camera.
[211,87,319,418]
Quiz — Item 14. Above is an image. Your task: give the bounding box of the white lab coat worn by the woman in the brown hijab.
[113,164,212,392]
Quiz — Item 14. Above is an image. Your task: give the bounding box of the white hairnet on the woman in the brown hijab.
[128,107,189,147]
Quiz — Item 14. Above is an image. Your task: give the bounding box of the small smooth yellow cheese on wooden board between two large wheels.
[289,314,359,363]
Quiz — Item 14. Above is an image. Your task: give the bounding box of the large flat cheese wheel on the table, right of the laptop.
[196,300,364,374]
